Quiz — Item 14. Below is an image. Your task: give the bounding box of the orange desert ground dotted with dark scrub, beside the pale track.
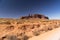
[0,18,60,40]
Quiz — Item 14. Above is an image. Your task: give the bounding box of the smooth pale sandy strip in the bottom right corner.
[29,28,60,40]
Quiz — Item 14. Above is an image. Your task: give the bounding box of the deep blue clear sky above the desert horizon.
[0,0,60,19]
